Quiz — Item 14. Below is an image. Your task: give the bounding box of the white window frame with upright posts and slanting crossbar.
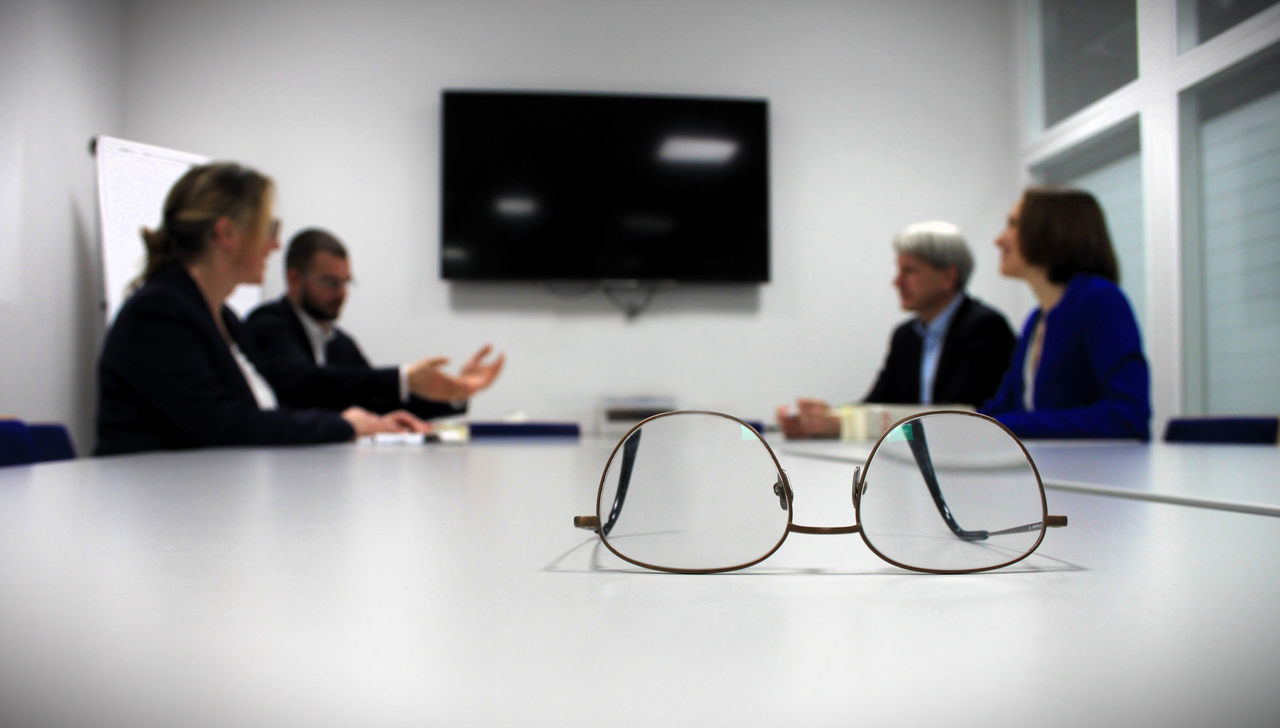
[1015,0,1280,422]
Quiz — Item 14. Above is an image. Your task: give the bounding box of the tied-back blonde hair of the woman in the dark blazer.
[136,162,274,284]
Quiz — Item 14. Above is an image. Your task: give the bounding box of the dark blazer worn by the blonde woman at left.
[93,264,355,455]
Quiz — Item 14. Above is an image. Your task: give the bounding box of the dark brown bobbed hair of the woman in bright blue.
[1018,187,1120,283]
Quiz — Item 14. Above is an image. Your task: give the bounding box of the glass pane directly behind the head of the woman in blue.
[1033,119,1147,333]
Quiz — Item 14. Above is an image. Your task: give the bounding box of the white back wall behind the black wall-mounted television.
[102,0,1025,432]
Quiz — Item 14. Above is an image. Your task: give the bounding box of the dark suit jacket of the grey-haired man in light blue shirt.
[865,294,1016,407]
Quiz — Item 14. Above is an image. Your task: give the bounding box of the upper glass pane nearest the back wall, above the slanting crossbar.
[1041,0,1138,127]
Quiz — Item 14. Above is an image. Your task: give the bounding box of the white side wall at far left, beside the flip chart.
[0,0,124,453]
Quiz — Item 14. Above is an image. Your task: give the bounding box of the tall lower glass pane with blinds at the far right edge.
[1188,48,1280,415]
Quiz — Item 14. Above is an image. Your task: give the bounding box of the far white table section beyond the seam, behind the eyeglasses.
[769,435,1280,516]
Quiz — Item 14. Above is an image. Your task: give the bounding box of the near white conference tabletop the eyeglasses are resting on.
[0,440,1280,728]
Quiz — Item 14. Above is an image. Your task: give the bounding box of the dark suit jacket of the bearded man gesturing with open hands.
[244,298,466,418]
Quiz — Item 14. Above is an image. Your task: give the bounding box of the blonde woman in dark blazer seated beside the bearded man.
[95,162,420,455]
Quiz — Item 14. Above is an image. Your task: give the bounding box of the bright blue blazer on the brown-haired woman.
[980,274,1151,440]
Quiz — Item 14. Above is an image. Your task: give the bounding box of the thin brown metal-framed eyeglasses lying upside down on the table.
[573,412,1066,573]
